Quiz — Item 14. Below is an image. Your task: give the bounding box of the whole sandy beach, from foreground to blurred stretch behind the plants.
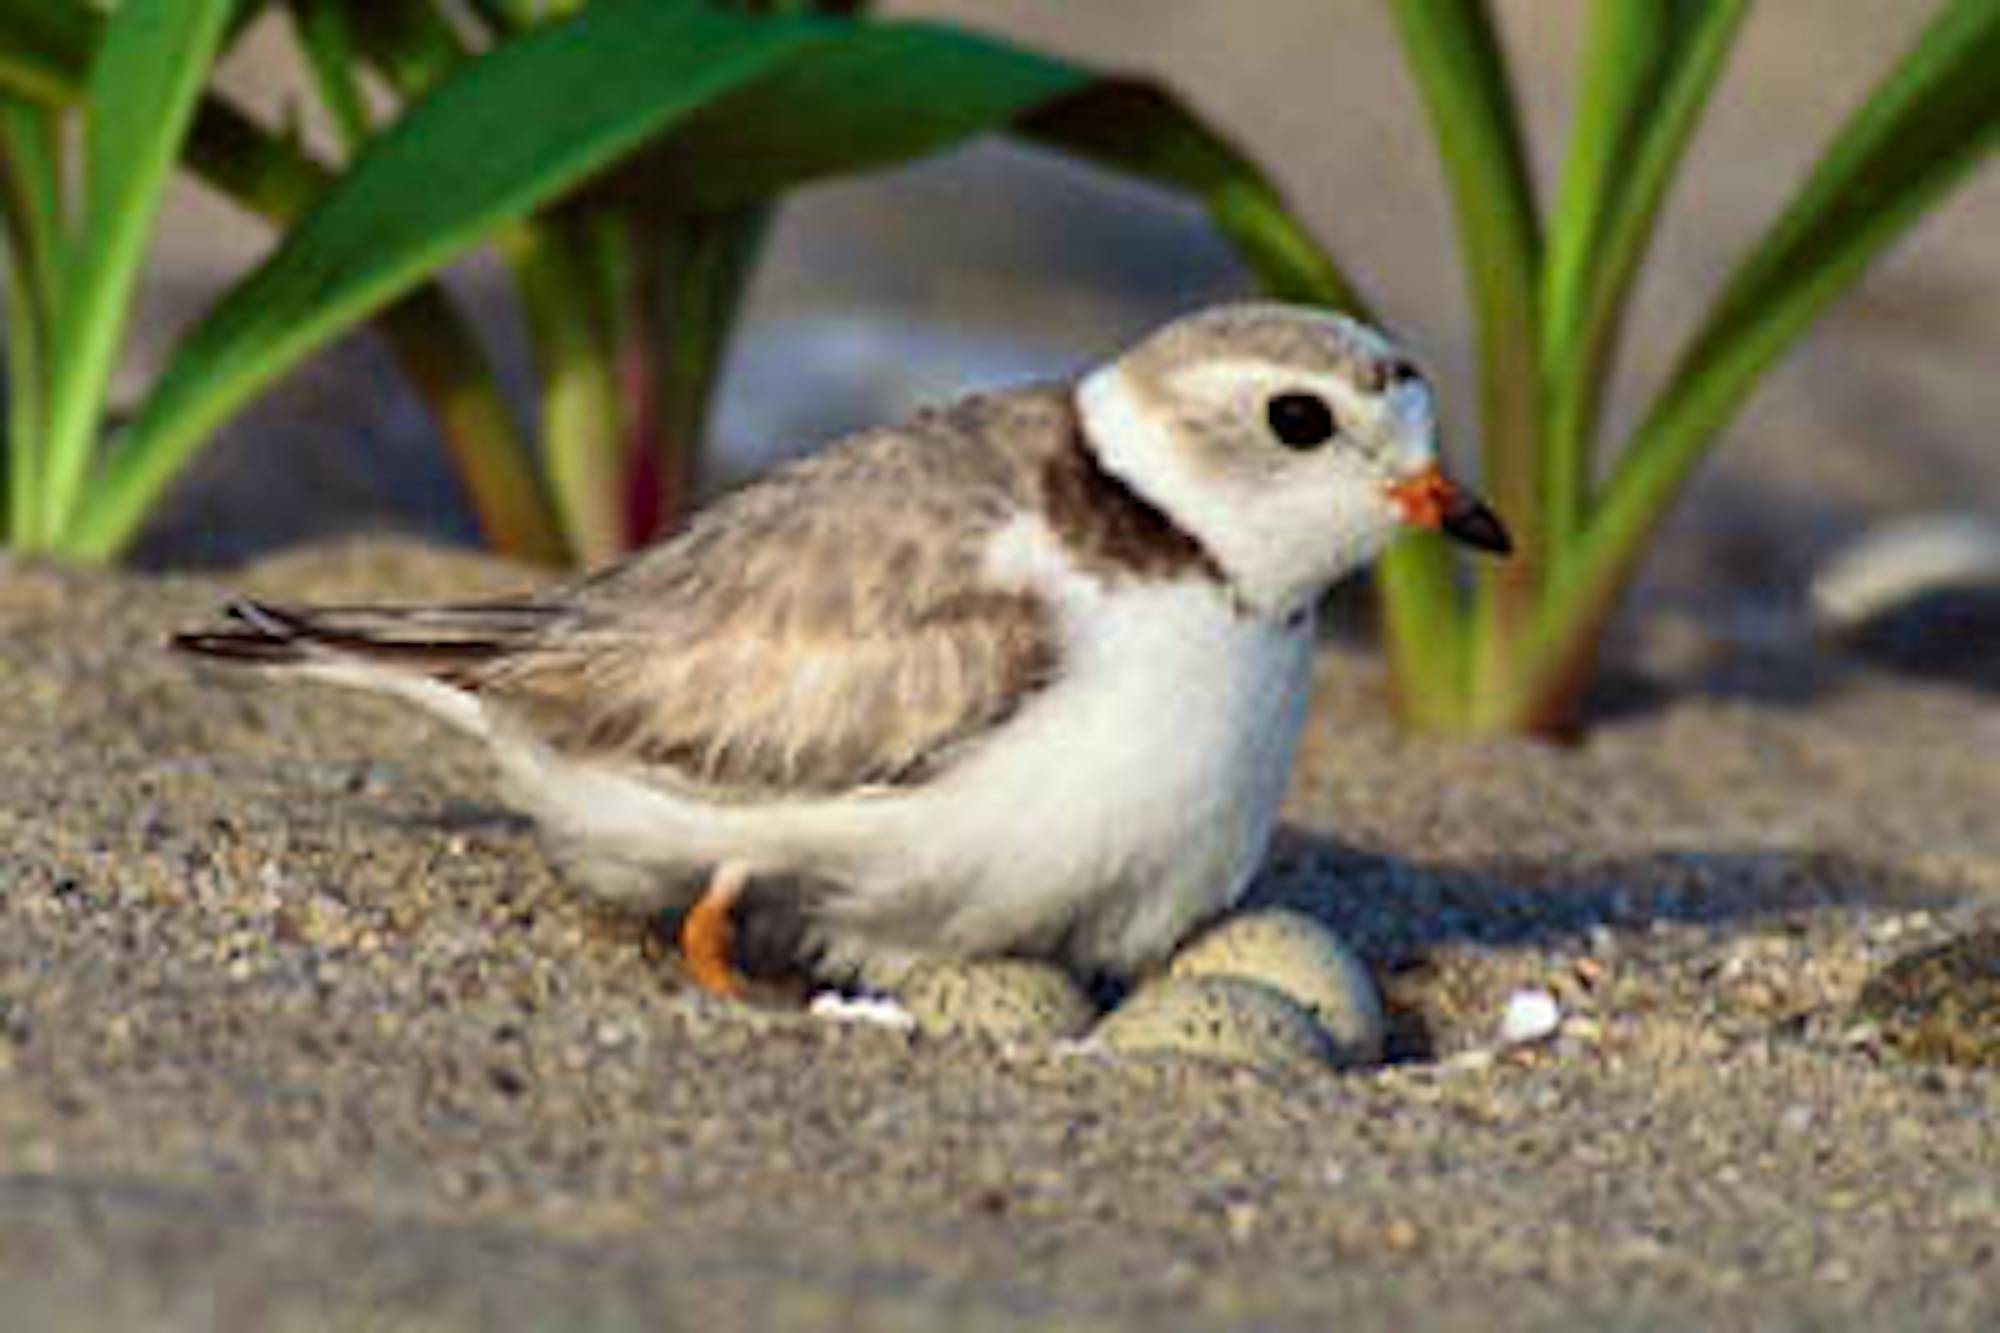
[0,0,2000,1333]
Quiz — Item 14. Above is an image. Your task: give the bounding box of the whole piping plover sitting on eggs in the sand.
[176,304,1508,993]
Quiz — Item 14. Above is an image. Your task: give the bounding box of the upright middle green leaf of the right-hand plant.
[1542,0,1750,560]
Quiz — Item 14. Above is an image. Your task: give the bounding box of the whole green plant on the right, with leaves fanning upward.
[1368,0,2000,735]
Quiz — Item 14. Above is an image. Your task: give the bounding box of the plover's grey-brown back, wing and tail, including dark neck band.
[176,388,1200,799]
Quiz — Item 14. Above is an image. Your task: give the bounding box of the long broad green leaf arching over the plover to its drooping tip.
[62,0,1348,554]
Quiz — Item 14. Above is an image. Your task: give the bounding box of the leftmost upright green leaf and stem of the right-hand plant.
[1384,0,1544,723]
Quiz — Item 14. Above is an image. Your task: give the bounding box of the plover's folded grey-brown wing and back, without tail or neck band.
[468,394,1074,795]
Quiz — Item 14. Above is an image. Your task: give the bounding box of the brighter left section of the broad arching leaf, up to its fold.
[74,0,824,554]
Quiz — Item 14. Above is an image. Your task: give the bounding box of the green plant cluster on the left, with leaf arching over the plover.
[0,0,1348,564]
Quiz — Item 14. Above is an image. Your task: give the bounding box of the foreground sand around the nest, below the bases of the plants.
[0,542,2000,1331]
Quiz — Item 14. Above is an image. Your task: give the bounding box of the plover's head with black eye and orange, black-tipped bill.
[1078,304,1510,612]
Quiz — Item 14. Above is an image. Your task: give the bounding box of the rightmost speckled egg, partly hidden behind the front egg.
[1168,909,1386,1065]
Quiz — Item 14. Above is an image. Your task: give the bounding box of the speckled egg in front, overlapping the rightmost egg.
[1090,964,1334,1069]
